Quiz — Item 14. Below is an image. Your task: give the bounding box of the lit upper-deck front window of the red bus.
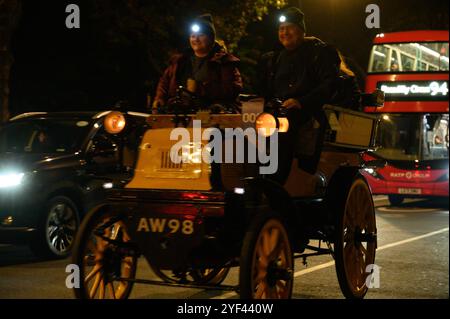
[369,42,449,73]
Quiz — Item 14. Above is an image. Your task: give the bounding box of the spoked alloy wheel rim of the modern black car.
[46,202,78,255]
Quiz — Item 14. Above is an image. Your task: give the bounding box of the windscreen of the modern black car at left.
[0,119,89,153]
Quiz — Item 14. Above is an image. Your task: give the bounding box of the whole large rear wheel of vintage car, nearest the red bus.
[335,178,377,298]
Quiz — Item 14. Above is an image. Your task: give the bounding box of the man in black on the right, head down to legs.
[259,7,340,173]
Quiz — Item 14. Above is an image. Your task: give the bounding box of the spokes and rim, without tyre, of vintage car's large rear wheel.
[342,181,376,297]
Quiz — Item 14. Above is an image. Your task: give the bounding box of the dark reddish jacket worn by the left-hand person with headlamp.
[155,43,243,108]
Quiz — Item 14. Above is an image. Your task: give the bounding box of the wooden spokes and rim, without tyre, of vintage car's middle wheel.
[251,219,293,299]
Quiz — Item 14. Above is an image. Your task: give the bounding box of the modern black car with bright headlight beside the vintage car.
[0,111,148,258]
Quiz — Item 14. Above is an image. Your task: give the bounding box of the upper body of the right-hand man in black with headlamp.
[260,7,341,115]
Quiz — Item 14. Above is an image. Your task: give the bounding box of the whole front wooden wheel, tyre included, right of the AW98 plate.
[239,214,294,299]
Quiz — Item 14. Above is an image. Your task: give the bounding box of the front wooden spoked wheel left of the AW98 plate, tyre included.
[73,210,137,299]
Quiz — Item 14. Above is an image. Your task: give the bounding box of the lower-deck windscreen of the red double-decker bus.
[375,114,449,160]
